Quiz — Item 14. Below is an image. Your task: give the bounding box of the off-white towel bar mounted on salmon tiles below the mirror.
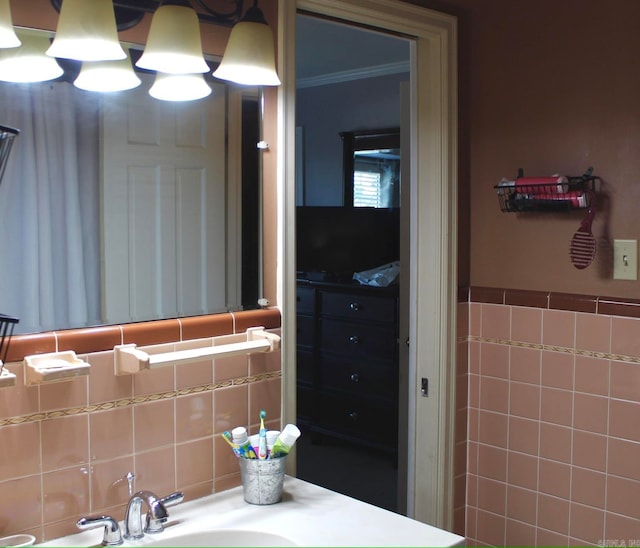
[113,327,280,375]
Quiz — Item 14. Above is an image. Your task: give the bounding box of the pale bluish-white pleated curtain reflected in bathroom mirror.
[0,82,101,333]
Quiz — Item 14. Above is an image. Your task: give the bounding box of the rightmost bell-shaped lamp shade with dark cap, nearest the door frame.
[213,0,280,86]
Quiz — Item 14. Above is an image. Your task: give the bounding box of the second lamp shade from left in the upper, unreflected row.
[47,0,127,61]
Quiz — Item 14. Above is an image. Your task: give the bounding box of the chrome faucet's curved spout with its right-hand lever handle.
[124,491,184,540]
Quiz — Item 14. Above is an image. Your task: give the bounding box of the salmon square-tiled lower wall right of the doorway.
[458,301,640,546]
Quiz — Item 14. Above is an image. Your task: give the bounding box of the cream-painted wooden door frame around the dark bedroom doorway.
[277,0,457,530]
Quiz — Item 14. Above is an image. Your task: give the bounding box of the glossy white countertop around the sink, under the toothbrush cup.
[41,476,465,546]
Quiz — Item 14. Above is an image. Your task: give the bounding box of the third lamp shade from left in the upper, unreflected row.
[136,5,209,74]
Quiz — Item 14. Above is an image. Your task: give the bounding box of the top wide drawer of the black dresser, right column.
[320,291,396,323]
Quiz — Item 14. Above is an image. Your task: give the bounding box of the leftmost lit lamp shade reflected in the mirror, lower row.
[0,30,64,83]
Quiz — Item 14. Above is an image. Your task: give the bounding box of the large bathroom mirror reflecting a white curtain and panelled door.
[0,36,261,333]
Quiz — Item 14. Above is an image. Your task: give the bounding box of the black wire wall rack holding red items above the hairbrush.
[494,168,600,213]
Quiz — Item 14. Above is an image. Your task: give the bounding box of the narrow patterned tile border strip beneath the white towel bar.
[0,371,282,427]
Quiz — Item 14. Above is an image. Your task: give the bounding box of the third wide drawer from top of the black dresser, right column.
[320,356,398,403]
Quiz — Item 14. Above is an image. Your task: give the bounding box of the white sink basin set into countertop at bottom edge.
[145,529,296,546]
